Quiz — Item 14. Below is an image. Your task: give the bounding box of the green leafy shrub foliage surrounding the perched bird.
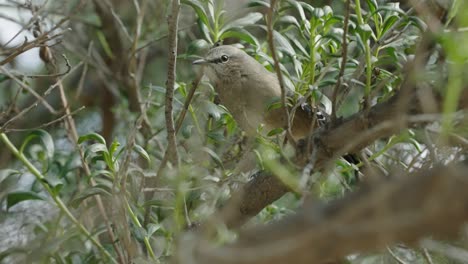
[0,0,468,263]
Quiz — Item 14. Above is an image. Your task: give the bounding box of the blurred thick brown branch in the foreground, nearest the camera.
[179,165,468,264]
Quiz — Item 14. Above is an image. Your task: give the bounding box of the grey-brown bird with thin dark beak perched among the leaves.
[193,45,316,139]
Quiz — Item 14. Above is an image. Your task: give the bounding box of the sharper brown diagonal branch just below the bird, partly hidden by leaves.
[221,89,468,228]
